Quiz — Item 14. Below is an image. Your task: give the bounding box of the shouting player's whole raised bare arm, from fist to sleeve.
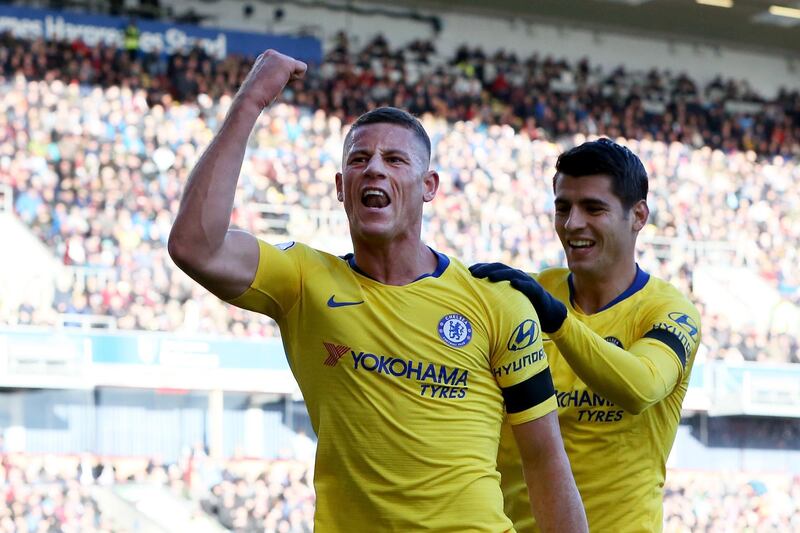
[168,50,306,300]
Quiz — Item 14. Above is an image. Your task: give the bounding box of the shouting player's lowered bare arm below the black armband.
[512,411,588,533]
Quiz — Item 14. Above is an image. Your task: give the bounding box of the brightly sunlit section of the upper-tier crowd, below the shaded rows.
[0,90,800,362]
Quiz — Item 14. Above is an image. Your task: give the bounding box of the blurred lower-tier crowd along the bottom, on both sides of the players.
[0,448,800,533]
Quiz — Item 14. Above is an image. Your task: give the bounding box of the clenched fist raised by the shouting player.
[237,49,308,109]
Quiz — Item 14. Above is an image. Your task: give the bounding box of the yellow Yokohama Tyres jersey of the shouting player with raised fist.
[231,242,556,533]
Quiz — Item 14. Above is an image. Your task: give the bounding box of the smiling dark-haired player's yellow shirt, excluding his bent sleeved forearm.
[498,268,700,533]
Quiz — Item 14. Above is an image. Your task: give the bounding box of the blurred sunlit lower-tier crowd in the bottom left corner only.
[0,454,315,533]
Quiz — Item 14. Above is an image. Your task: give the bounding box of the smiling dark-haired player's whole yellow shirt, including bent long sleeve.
[498,267,700,533]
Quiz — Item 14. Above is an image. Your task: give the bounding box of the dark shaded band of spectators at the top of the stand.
[0,33,800,156]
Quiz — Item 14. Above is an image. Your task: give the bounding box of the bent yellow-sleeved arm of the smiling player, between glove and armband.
[550,315,688,414]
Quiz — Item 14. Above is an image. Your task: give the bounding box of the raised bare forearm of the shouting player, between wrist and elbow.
[170,96,261,256]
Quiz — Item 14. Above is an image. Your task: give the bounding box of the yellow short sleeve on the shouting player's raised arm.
[228,239,307,320]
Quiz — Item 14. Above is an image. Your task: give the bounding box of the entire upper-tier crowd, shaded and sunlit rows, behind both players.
[0,35,800,362]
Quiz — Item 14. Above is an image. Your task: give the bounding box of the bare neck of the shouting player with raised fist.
[353,238,439,285]
